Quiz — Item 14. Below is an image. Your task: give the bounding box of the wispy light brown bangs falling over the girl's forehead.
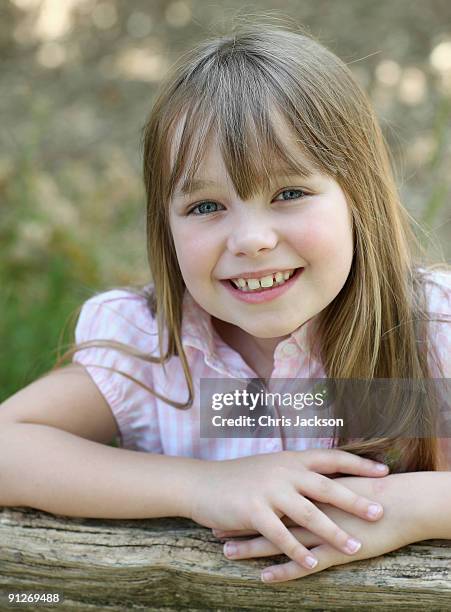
[168,84,320,200]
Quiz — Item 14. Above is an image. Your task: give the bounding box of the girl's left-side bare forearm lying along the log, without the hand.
[0,423,203,518]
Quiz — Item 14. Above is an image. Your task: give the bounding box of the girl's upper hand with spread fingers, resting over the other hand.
[191,449,388,569]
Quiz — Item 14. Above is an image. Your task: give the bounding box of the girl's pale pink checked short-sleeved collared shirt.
[73,272,451,469]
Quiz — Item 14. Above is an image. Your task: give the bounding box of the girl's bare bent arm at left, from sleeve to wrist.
[0,364,202,518]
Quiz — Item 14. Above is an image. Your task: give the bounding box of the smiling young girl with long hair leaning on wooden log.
[0,24,451,581]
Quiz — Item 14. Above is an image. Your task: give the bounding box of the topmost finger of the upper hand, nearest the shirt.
[304,448,389,476]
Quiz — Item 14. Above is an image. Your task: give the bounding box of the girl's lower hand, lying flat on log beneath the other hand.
[213,474,427,582]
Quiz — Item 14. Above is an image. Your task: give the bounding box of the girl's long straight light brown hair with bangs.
[53,17,451,471]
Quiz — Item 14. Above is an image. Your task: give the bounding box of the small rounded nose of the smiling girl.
[227,214,277,257]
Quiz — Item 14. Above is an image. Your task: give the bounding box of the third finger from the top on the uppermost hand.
[282,494,362,555]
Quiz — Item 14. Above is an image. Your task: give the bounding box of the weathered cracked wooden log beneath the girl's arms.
[0,508,451,611]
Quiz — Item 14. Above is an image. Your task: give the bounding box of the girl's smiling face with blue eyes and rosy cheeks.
[170,117,353,338]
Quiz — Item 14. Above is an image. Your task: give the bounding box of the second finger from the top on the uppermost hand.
[296,472,384,521]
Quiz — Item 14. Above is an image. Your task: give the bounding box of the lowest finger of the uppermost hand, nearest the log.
[253,504,318,569]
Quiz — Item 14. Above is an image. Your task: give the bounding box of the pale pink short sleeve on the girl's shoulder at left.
[72,289,163,453]
